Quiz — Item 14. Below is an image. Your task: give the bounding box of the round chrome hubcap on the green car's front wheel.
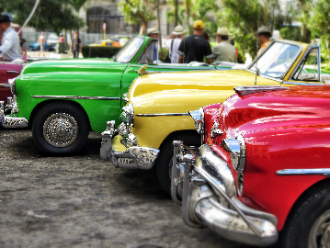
[43,113,78,147]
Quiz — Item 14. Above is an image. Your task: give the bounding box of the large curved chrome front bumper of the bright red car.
[172,141,278,246]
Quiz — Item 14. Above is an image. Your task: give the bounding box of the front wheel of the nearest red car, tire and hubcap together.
[281,185,330,248]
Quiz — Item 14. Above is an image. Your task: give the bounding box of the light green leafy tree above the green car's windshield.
[118,0,156,34]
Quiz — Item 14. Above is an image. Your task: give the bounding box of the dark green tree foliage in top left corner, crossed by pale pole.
[0,0,84,33]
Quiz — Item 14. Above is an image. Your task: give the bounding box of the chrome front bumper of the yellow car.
[100,121,159,170]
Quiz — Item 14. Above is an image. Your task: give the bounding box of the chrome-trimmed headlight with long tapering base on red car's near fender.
[222,135,246,195]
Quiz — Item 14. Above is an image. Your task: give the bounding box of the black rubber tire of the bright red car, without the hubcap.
[280,186,330,248]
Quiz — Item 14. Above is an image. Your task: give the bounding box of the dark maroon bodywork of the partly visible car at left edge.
[0,63,23,101]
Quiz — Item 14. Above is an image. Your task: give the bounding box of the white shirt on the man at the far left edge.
[0,27,22,61]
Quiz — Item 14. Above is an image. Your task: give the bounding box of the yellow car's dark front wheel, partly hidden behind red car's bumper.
[156,133,201,195]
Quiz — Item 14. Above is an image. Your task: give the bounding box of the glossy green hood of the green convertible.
[22,58,123,75]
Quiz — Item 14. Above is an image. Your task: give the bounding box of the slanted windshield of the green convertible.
[115,37,144,63]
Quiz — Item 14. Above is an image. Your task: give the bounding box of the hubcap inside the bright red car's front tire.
[308,210,330,248]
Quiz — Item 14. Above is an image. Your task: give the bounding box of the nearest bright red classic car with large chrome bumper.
[172,86,330,248]
